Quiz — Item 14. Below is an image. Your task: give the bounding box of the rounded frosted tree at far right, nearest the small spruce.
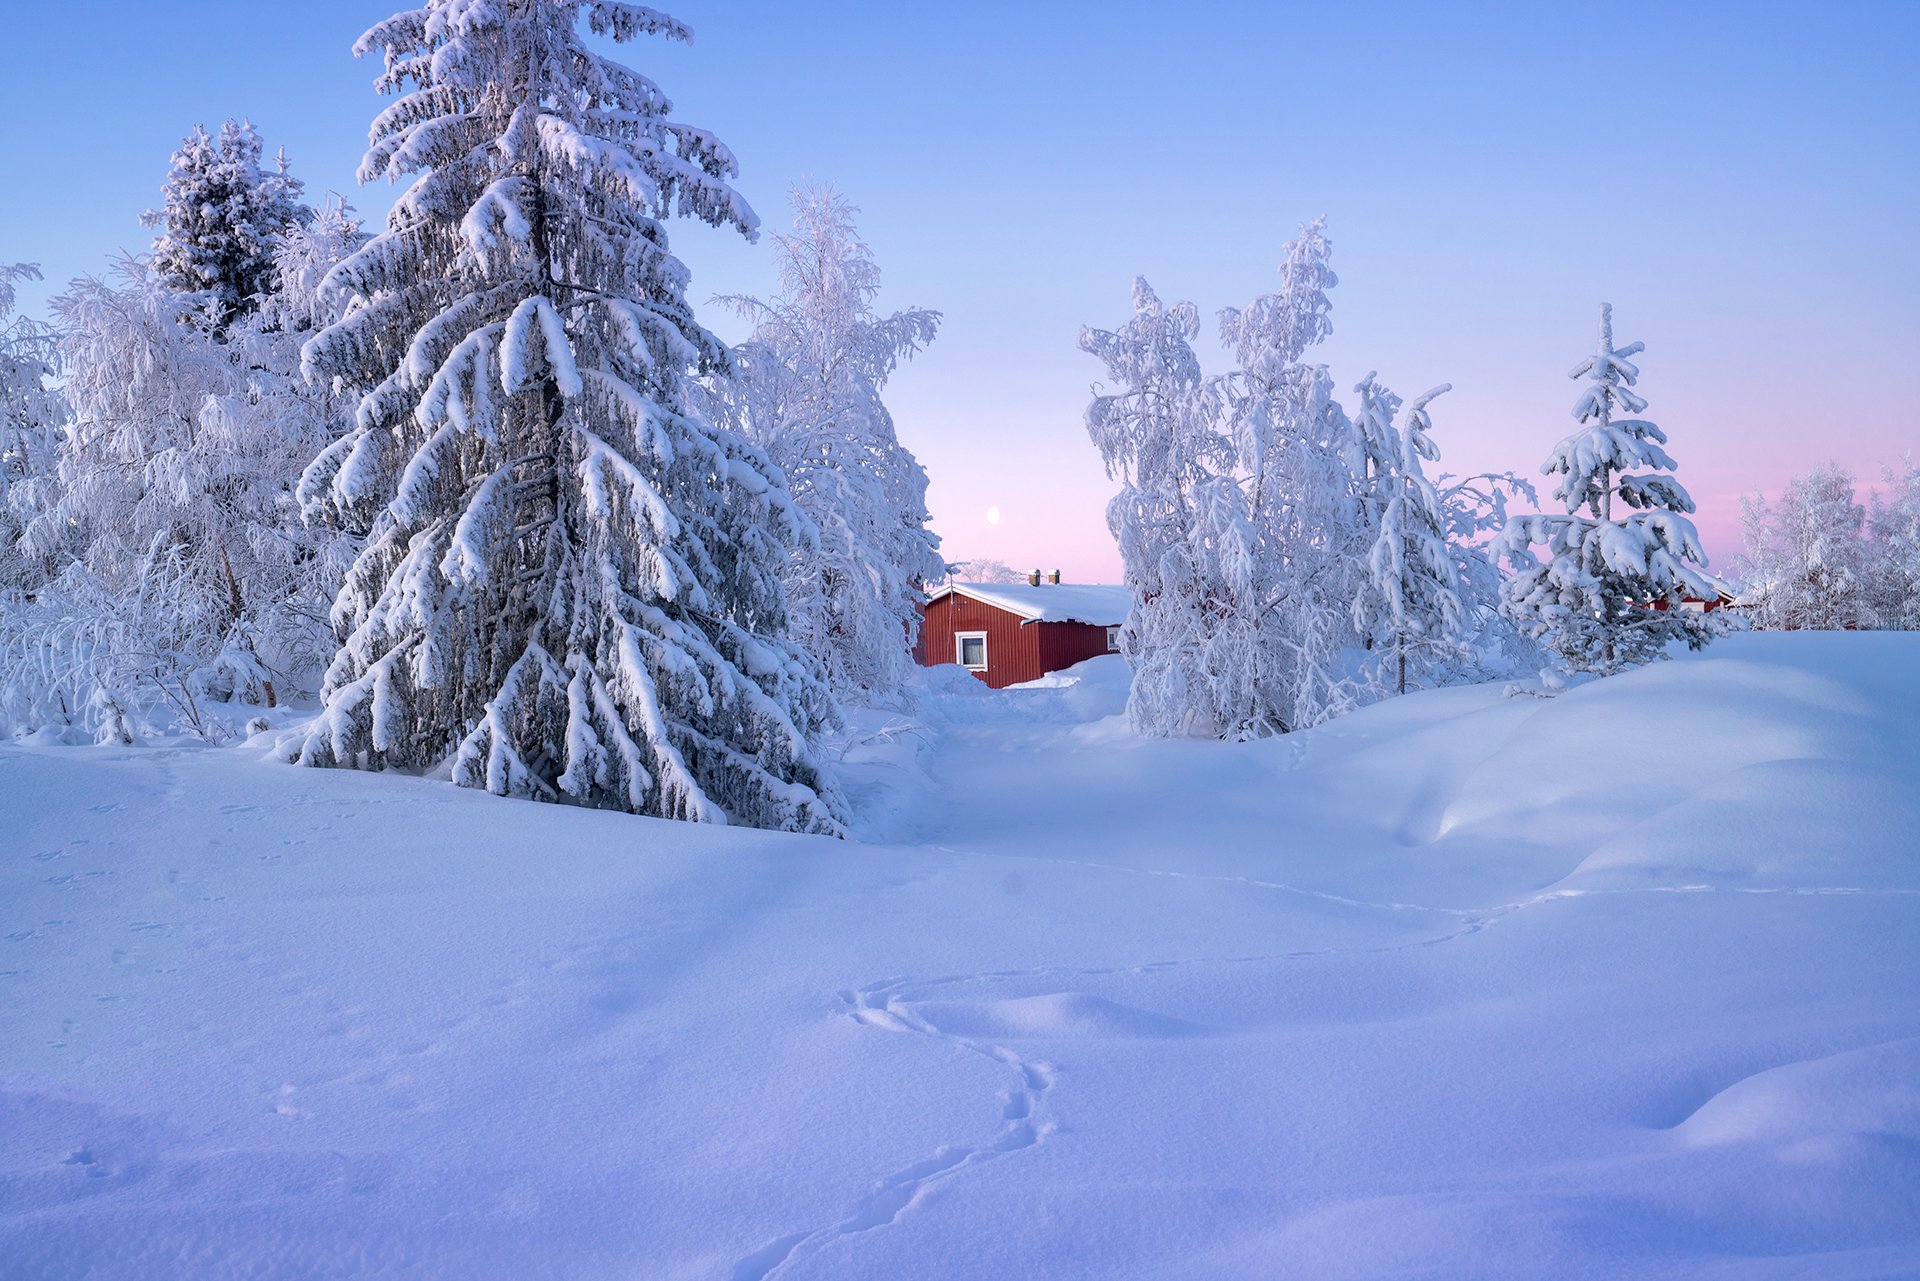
[1741,463,1874,630]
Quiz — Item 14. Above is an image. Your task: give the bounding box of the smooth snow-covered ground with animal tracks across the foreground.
[0,632,1920,1281]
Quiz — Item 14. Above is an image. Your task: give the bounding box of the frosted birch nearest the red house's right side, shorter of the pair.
[1079,280,1244,737]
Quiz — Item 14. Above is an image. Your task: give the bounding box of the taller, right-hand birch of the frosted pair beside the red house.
[1219,219,1367,736]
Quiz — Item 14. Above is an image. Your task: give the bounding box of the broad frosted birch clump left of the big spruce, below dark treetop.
[2,221,360,734]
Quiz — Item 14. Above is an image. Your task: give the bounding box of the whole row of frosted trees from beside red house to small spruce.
[1081,234,1724,739]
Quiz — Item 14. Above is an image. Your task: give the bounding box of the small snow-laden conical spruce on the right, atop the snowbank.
[1500,303,1722,676]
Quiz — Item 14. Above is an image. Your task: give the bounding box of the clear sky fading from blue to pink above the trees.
[0,0,1920,580]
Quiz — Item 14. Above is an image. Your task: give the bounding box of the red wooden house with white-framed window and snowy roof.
[914,574,1131,689]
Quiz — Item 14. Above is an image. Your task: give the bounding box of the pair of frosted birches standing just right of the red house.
[1081,221,1398,739]
